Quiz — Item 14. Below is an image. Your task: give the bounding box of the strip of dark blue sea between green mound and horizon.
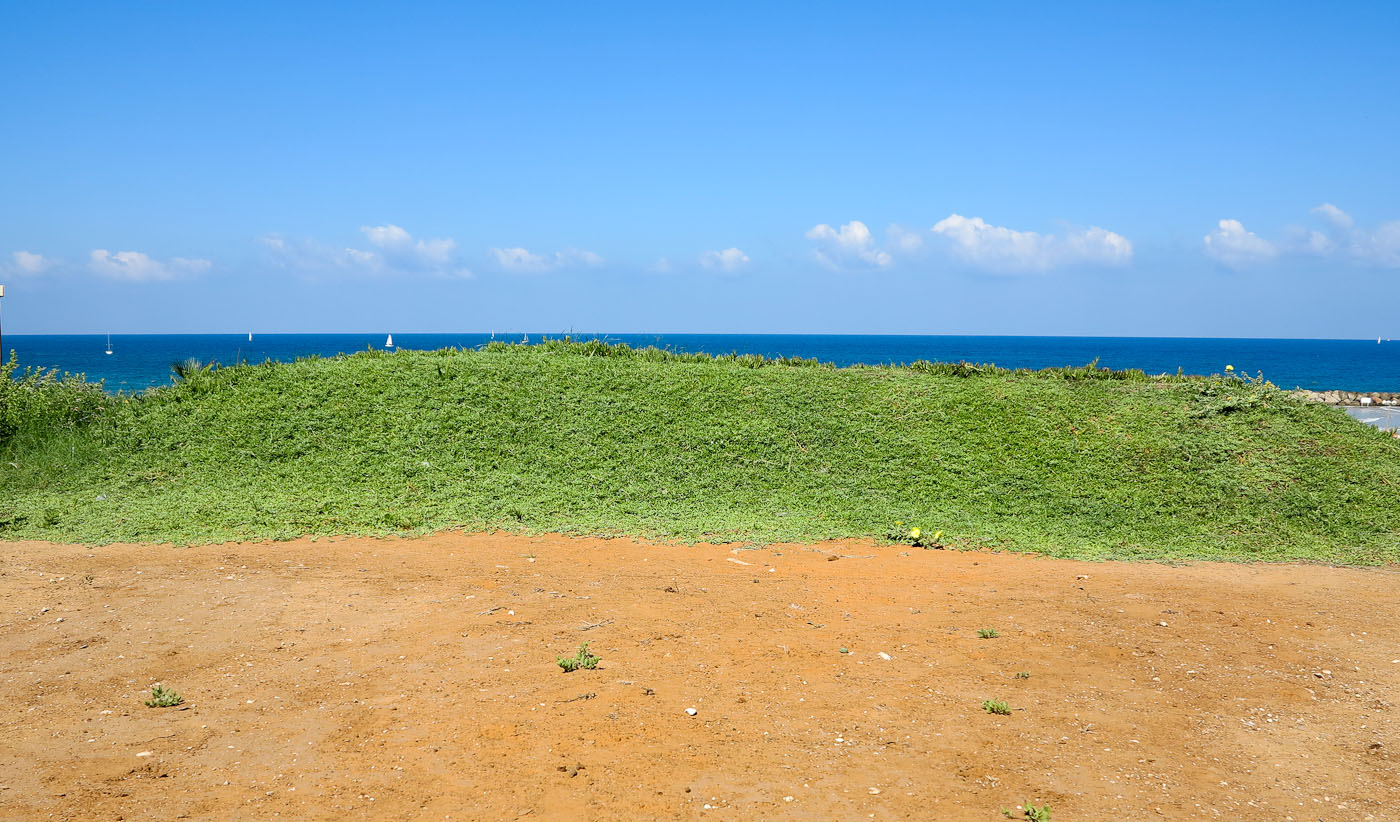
[4,333,1400,391]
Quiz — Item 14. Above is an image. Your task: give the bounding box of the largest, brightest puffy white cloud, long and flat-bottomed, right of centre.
[932,214,1133,272]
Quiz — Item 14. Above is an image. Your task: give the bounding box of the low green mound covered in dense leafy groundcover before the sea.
[0,340,1400,563]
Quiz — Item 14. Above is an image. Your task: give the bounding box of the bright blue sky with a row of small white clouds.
[0,0,1400,337]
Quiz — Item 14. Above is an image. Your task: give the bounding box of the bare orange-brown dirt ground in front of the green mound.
[0,534,1400,822]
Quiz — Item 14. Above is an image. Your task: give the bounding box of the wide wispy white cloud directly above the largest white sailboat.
[258,223,472,277]
